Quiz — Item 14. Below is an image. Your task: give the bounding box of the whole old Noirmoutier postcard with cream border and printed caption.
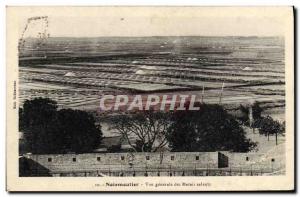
[6,6,295,192]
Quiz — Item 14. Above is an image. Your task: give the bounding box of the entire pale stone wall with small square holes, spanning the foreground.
[20,151,285,177]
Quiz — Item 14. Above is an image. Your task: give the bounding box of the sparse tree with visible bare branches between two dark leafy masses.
[112,110,170,152]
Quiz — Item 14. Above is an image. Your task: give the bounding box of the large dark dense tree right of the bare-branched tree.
[167,103,256,152]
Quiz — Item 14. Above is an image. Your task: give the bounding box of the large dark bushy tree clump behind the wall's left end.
[19,98,102,154]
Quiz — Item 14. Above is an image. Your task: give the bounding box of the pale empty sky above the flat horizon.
[16,6,285,37]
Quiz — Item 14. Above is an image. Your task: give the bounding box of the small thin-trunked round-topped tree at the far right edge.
[257,116,285,145]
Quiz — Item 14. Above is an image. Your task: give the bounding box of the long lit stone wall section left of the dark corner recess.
[25,152,228,176]
